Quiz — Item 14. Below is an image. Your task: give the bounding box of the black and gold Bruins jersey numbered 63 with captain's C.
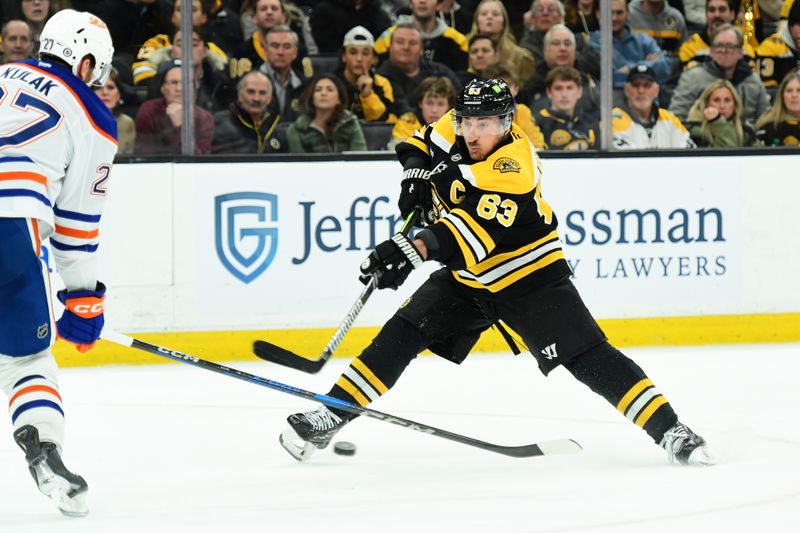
[397,110,570,293]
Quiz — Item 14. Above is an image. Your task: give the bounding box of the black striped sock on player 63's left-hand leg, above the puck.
[329,316,424,419]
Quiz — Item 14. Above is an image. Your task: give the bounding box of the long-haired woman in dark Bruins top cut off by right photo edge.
[756,71,800,146]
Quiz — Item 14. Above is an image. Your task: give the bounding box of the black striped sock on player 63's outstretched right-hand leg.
[564,342,678,444]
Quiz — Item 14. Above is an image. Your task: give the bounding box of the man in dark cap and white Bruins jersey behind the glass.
[611,64,695,150]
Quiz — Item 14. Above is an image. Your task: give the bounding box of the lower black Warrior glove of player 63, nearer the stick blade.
[358,233,423,290]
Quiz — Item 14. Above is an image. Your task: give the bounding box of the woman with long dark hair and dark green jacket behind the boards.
[286,74,367,154]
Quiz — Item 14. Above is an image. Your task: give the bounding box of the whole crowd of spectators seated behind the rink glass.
[0,0,800,155]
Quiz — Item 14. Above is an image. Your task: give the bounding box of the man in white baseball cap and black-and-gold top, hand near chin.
[334,26,397,123]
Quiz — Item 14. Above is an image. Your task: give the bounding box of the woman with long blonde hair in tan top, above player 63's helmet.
[467,0,534,86]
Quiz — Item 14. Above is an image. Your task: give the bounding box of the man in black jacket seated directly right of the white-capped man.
[377,23,461,116]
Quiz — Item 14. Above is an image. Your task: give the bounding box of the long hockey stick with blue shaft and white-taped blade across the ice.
[102,328,581,457]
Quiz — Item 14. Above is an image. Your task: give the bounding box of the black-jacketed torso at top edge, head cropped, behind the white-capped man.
[311,0,392,53]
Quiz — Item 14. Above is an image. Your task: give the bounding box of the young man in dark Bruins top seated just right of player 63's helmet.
[534,67,597,150]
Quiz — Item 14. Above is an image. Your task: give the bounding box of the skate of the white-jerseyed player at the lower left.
[14,426,89,516]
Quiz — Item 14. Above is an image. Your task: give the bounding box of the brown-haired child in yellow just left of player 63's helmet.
[389,76,456,149]
